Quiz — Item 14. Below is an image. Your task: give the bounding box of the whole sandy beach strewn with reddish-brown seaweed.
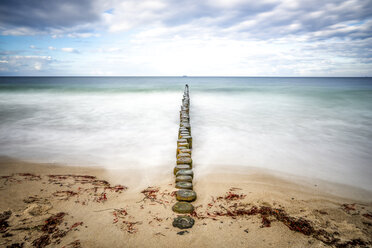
[0,157,372,247]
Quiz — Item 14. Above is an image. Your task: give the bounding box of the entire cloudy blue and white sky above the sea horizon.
[0,0,372,77]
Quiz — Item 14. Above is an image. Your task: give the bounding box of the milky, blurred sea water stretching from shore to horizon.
[0,77,372,190]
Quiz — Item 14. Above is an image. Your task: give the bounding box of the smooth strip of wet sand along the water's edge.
[0,156,372,203]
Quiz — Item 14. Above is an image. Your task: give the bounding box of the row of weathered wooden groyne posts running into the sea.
[172,84,196,229]
